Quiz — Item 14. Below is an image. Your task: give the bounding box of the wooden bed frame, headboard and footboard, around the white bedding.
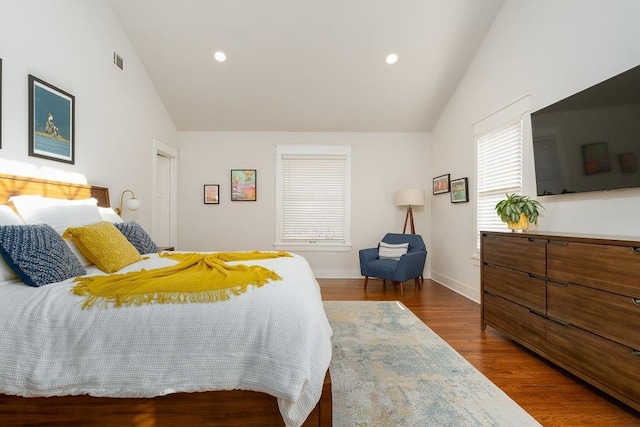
[0,174,333,427]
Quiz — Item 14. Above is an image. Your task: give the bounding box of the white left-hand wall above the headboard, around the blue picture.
[0,0,178,234]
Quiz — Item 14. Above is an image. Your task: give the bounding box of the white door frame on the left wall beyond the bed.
[151,136,180,249]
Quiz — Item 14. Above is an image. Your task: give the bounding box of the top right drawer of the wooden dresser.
[547,240,640,298]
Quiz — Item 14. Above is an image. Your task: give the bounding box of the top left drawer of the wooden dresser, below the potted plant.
[482,233,547,276]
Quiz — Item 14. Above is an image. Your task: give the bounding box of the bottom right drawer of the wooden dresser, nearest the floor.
[547,322,640,404]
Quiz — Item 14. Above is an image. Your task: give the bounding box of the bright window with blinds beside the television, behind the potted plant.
[476,119,523,251]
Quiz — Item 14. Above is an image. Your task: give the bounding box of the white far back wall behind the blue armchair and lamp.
[179,132,432,277]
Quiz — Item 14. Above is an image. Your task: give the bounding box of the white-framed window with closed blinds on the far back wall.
[275,145,351,251]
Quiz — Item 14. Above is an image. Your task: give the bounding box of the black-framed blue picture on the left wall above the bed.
[29,75,76,164]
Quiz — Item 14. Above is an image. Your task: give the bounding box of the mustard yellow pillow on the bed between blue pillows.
[62,221,142,273]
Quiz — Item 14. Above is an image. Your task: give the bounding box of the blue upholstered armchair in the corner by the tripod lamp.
[360,233,427,295]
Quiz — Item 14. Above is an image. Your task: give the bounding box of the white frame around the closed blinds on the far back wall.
[274,145,351,252]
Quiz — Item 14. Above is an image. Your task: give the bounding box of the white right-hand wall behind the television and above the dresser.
[431,0,640,300]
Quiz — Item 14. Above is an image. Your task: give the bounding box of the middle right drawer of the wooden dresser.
[547,283,640,349]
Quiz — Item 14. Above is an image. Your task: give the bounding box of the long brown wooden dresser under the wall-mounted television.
[481,232,640,410]
